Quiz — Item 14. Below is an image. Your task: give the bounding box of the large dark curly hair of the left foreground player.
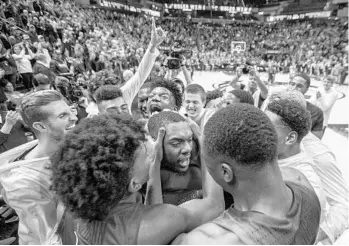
[51,114,145,220]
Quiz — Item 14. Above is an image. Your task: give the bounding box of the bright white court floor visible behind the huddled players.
[193,71,349,184]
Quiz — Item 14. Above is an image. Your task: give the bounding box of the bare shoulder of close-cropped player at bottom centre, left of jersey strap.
[181,222,242,245]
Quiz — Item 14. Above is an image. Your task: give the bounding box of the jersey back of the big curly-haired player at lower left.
[77,203,147,245]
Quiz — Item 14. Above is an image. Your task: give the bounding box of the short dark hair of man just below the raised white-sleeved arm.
[88,70,122,99]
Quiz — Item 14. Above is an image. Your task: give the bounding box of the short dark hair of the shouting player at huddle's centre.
[148,111,185,140]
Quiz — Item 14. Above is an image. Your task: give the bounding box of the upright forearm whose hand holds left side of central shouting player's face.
[145,160,163,205]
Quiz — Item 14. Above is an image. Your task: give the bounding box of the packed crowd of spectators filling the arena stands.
[0,0,348,95]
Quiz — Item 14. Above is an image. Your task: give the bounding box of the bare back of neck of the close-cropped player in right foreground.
[231,164,292,217]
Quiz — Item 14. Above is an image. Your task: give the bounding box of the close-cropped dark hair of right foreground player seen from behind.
[204,103,277,170]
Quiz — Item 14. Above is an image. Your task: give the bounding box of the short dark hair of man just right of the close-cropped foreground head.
[267,99,311,143]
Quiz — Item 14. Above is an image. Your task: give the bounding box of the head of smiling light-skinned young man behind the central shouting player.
[184,84,206,119]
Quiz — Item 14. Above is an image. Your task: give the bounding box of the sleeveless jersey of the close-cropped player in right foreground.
[213,182,321,245]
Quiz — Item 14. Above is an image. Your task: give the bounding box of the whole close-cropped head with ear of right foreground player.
[203,103,277,191]
